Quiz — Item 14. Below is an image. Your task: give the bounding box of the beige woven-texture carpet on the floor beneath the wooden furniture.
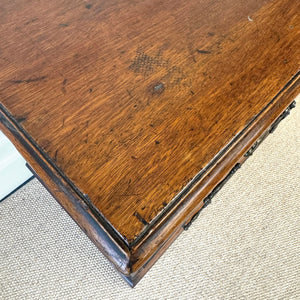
[0,93,300,299]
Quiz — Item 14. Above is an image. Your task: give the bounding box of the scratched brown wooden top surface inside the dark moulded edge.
[0,0,300,244]
